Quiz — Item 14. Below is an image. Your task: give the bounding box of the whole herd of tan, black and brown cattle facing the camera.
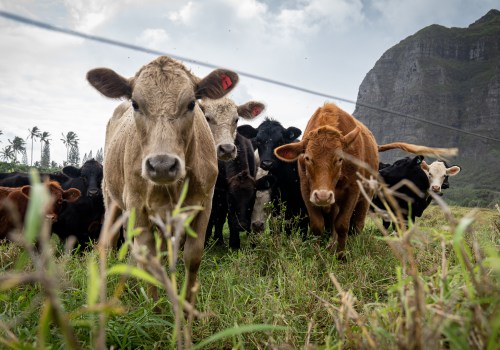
[0,56,460,300]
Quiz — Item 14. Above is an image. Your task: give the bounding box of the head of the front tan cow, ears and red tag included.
[87,56,238,185]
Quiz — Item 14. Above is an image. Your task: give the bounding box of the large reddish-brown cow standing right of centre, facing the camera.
[274,103,378,258]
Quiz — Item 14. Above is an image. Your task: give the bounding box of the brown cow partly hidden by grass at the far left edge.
[0,181,80,239]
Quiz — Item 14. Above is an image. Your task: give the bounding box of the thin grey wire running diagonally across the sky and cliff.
[0,10,500,142]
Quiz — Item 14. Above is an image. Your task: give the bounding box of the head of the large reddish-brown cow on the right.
[274,126,360,206]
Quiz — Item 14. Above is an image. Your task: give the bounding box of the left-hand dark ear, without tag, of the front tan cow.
[87,68,132,98]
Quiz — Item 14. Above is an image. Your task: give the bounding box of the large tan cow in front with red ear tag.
[87,56,238,302]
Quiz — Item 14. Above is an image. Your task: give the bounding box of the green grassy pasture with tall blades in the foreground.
[0,196,500,349]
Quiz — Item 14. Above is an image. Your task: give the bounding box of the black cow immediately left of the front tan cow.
[52,159,104,248]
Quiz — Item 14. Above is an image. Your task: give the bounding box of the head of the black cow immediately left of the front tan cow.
[62,159,103,197]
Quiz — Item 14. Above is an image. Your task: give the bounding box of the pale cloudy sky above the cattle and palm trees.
[0,0,500,164]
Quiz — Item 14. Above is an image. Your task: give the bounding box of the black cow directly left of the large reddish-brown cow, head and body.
[238,118,308,236]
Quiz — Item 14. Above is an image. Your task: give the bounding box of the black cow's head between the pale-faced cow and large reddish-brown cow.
[238,118,302,170]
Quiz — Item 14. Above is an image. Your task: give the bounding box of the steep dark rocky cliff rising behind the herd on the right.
[353,10,500,205]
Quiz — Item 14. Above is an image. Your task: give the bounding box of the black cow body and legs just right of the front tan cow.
[205,134,269,249]
